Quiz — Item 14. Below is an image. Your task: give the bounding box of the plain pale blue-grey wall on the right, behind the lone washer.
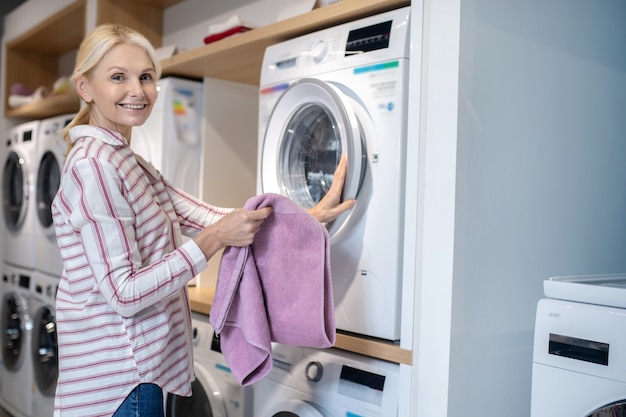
[444,0,626,417]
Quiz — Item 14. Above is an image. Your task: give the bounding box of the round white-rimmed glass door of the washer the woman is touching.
[260,78,366,238]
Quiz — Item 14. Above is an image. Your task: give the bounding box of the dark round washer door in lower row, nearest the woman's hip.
[31,306,59,396]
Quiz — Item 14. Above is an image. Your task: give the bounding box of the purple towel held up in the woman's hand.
[210,194,335,385]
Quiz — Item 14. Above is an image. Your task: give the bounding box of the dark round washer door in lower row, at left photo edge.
[0,292,26,372]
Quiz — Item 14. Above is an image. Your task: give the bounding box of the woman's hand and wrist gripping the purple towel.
[193,207,272,260]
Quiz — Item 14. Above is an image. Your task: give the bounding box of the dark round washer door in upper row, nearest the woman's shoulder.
[36,152,61,229]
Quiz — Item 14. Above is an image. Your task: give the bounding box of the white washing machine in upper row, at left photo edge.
[2,121,40,269]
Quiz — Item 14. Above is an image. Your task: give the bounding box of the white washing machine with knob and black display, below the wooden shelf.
[252,342,400,417]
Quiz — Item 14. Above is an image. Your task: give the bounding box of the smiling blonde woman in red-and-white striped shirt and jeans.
[52,25,355,417]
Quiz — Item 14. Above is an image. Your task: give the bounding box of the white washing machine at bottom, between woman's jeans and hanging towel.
[164,313,253,417]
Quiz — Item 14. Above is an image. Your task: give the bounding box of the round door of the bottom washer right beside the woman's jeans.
[165,361,228,417]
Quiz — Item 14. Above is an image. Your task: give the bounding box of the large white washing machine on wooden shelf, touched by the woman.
[257,7,410,340]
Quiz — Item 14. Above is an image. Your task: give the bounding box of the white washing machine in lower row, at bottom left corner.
[0,264,33,417]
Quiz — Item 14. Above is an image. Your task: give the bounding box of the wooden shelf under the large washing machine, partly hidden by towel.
[189,287,413,365]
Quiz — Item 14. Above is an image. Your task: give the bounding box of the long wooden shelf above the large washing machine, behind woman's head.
[161,0,410,85]
